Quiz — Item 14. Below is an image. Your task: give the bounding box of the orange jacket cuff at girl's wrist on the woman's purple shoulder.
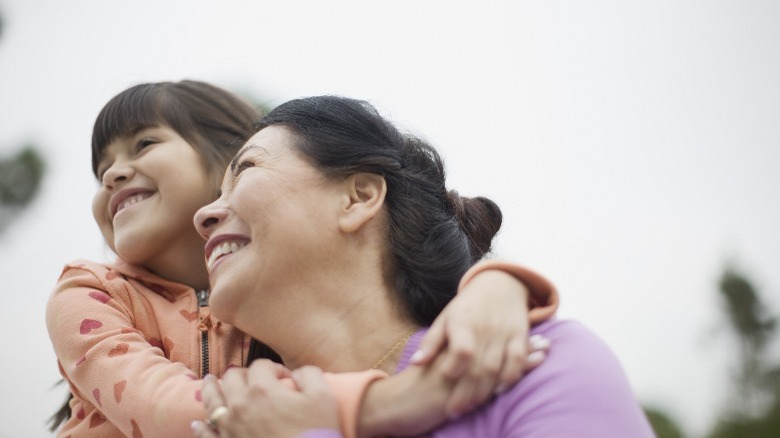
[458,259,559,326]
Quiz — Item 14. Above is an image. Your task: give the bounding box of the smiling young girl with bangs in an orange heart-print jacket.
[46,81,557,437]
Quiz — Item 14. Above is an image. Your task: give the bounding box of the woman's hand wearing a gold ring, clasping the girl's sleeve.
[193,360,339,438]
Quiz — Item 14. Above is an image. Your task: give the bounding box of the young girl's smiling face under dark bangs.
[92,126,216,276]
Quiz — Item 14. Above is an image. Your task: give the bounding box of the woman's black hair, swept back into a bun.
[257,96,502,325]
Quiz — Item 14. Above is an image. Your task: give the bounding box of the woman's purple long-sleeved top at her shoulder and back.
[306,320,655,438]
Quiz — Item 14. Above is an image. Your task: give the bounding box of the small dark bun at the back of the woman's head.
[447,190,503,260]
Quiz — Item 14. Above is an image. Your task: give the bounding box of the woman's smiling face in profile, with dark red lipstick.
[195,126,343,330]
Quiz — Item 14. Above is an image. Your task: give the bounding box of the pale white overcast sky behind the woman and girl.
[0,0,780,437]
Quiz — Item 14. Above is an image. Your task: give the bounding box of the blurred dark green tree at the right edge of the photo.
[709,267,780,438]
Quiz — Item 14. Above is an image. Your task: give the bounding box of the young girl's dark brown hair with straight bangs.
[92,80,260,176]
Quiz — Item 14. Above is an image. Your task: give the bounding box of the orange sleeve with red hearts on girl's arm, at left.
[46,265,206,437]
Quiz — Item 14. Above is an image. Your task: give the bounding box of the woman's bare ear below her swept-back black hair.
[339,172,387,233]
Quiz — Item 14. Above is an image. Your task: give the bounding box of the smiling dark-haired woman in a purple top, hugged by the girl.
[195,96,652,437]
